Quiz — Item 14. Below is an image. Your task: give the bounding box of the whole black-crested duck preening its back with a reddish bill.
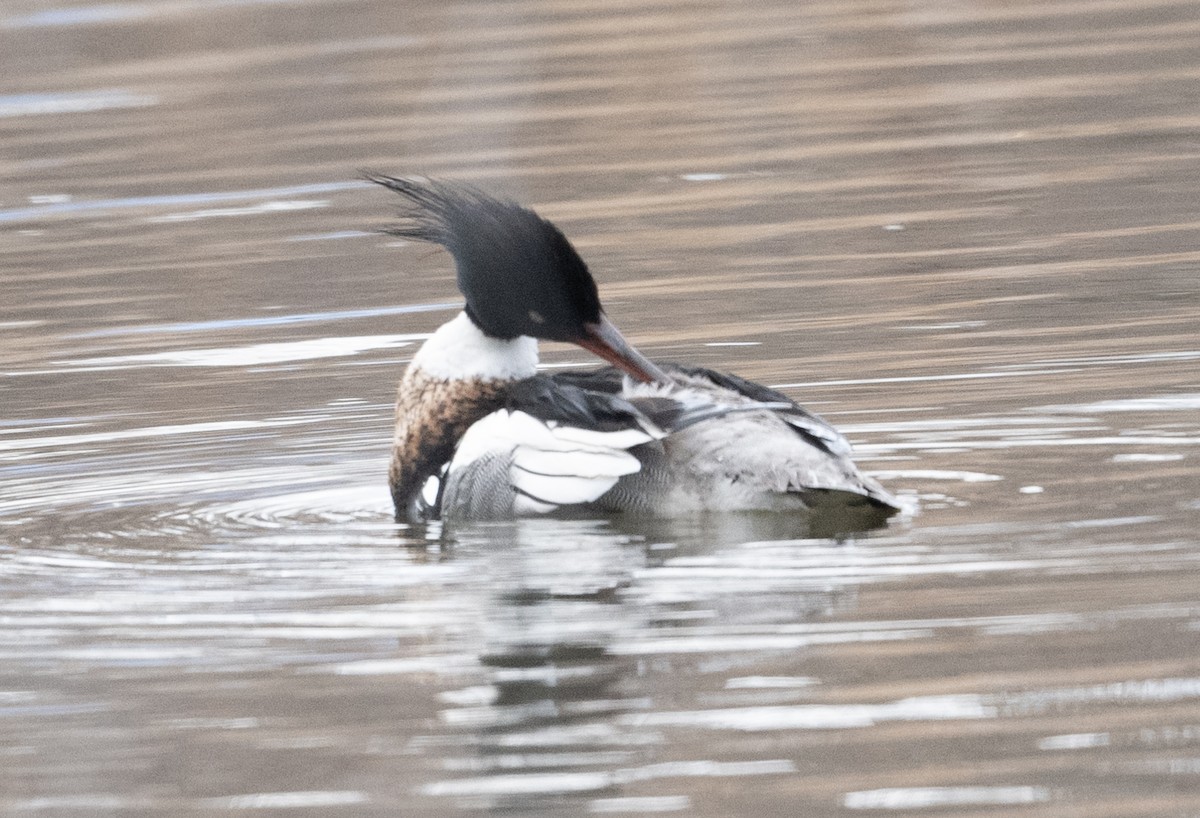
[365,173,901,529]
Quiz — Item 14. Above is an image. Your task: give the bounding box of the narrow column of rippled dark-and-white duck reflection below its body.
[425,519,662,808]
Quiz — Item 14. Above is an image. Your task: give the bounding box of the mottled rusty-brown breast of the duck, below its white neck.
[388,366,512,518]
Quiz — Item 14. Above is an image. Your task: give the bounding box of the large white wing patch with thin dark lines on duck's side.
[450,409,664,515]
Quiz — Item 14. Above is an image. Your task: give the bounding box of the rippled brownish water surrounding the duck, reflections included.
[0,0,1200,818]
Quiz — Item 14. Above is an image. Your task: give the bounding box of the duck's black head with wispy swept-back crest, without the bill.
[366,174,600,341]
